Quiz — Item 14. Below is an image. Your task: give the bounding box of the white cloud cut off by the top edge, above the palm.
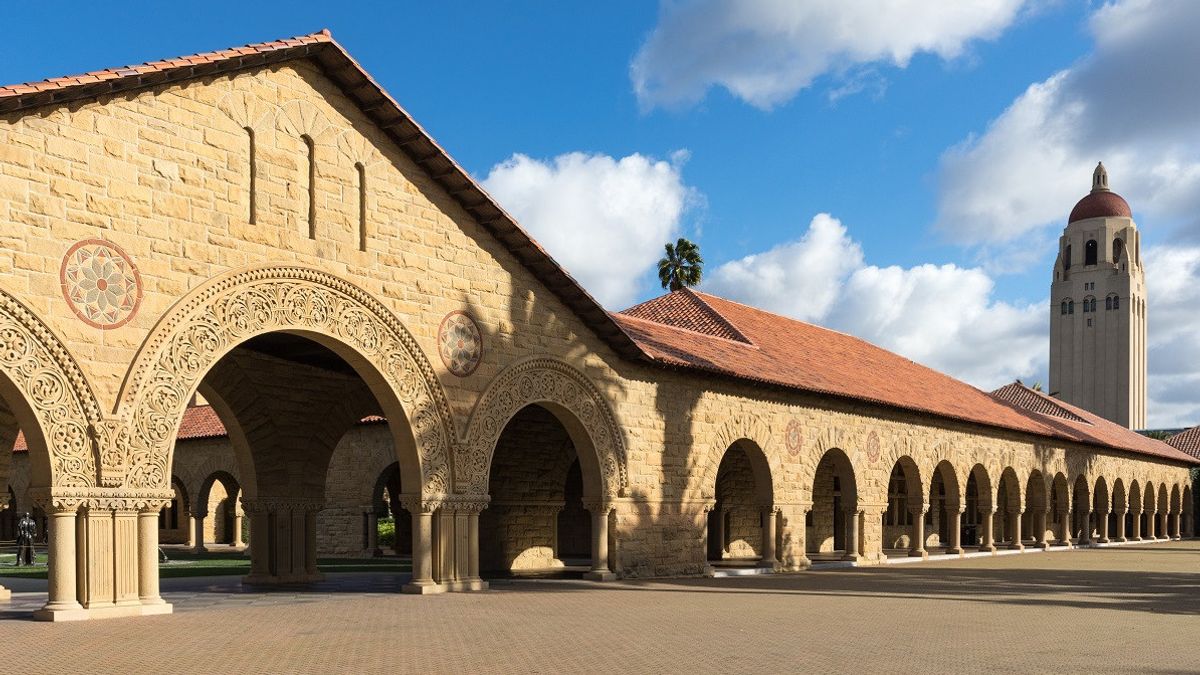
[630,0,1027,108]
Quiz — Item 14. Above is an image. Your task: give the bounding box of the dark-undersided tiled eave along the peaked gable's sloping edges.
[0,30,648,360]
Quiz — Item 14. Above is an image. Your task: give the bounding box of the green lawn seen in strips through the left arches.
[0,551,412,579]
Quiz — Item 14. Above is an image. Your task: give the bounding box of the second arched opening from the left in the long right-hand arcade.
[805,448,863,561]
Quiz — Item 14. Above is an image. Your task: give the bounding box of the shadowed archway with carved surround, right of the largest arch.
[456,357,626,580]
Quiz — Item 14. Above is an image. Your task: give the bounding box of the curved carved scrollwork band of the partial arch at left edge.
[0,291,100,488]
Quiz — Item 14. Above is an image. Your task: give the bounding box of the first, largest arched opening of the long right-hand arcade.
[708,438,780,569]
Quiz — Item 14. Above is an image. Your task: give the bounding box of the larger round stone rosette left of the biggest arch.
[59,239,142,330]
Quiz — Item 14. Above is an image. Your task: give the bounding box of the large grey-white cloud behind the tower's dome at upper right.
[938,0,1200,245]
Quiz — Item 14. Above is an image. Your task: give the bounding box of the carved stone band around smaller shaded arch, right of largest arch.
[455,357,629,498]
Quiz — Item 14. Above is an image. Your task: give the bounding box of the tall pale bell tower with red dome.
[1050,163,1146,429]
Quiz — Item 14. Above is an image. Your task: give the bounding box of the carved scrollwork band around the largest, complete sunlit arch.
[119,267,455,497]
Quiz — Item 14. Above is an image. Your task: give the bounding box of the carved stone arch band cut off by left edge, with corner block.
[0,283,100,488]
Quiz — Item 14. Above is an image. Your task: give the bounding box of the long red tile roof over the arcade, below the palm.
[613,291,1193,461]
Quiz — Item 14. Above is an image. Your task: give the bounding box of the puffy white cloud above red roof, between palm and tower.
[704,214,1049,389]
